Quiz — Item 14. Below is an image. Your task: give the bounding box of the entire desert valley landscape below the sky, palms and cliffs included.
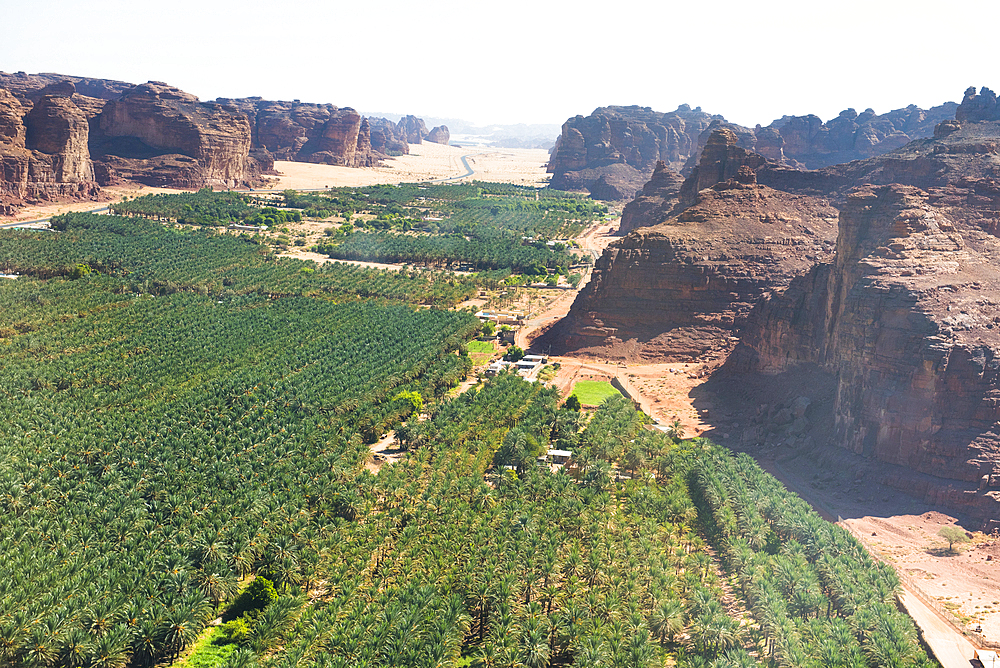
[0,66,1000,668]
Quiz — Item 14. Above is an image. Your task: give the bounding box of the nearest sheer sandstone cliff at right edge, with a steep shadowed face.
[721,185,1000,504]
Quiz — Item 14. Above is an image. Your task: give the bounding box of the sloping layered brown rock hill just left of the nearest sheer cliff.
[547,136,837,360]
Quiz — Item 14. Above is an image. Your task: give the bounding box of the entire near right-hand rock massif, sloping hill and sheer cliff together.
[549,89,1000,520]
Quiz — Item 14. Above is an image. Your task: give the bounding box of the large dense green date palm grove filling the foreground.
[0,185,930,668]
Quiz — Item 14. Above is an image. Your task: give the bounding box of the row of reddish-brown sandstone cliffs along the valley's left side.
[0,72,434,214]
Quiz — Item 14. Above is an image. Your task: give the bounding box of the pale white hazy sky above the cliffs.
[0,0,1000,126]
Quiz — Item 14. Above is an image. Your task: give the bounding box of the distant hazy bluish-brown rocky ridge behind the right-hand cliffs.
[548,99,956,200]
